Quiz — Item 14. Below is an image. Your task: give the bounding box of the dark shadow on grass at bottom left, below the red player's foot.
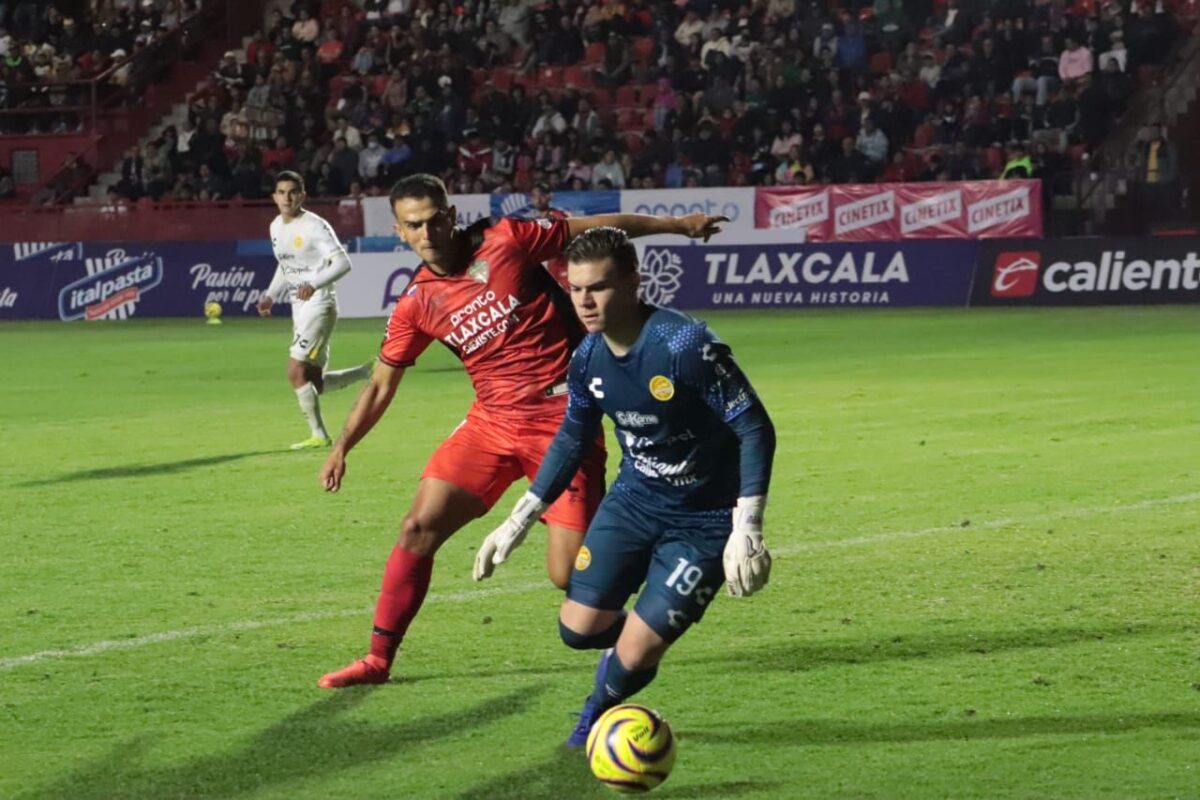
[26,687,544,800]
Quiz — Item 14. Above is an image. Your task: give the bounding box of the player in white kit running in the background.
[258,172,364,450]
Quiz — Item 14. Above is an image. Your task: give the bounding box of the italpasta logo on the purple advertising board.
[59,248,162,321]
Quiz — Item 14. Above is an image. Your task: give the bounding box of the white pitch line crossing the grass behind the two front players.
[0,492,1200,672]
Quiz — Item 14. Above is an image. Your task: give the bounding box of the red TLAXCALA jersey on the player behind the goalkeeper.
[379,219,582,417]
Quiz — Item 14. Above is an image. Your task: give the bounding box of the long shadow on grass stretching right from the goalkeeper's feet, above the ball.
[404,625,1161,682]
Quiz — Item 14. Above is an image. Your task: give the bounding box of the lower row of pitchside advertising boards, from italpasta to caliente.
[0,236,1200,321]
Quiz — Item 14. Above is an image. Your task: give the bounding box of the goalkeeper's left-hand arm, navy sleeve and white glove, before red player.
[473,347,602,581]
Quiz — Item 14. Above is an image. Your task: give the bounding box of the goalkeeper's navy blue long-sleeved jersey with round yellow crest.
[532,308,773,511]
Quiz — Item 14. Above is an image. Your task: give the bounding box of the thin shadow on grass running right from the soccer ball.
[679,711,1200,747]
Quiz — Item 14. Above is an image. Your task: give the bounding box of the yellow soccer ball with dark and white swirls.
[587,704,676,793]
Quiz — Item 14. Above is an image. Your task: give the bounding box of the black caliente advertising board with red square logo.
[971,236,1200,306]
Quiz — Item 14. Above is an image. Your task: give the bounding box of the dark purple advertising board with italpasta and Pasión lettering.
[0,241,275,321]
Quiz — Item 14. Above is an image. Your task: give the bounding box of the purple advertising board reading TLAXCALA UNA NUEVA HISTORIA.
[638,241,979,308]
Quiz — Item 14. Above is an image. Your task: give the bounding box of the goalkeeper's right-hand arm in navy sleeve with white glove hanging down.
[677,330,775,597]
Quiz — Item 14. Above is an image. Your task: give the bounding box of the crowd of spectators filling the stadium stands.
[0,0,1181,200]
